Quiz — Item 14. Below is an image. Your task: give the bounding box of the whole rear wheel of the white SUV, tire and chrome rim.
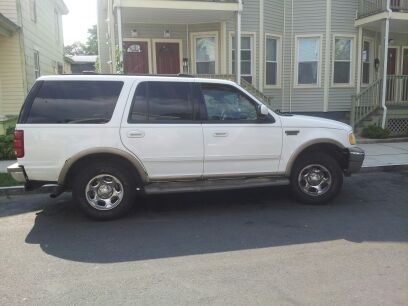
[72,162,136,220]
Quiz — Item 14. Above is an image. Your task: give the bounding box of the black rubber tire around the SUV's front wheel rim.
[290,153,343,205]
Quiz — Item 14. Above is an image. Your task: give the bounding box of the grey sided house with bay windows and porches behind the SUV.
[97,0,408,135]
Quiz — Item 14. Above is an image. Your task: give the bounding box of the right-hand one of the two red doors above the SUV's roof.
[155,42,180,74]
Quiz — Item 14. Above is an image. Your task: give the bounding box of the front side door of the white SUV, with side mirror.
[201,83,282,177]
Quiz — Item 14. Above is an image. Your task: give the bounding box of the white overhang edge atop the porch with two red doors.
[114,0,240,24]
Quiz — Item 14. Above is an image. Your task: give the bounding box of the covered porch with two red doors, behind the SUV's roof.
[106,0,245,83]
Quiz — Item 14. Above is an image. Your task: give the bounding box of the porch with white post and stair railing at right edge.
[350,0,408,135]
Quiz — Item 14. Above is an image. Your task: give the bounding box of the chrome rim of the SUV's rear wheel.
[85,174,124,210]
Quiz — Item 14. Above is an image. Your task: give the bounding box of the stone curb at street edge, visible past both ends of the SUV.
[0,164,408,196]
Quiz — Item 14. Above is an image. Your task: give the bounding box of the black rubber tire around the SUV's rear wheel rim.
[72,162,137,220]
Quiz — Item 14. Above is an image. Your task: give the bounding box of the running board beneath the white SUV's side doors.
[144,176,289,194]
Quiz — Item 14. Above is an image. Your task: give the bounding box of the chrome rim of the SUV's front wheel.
[298,164,332,196]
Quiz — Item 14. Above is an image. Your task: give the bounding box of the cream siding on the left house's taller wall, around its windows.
[21,0,64,88]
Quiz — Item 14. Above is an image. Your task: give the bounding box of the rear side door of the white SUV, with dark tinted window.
[121,81,204,180]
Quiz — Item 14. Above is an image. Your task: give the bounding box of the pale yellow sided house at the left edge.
[0,0,68,119]
